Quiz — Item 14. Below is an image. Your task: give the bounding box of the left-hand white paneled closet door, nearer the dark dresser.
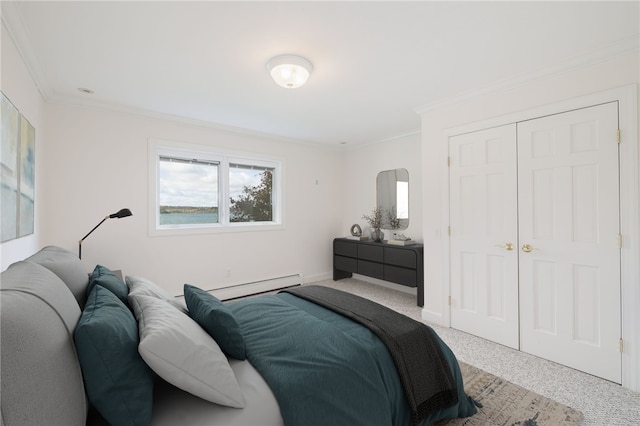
[449,124,518,348]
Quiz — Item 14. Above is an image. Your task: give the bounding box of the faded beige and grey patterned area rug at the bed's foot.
[435,362,582,426]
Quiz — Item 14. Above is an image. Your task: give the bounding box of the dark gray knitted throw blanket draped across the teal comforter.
[283,285,458,423]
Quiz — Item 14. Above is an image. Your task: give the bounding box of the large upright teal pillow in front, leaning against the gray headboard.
[74,285,154,425]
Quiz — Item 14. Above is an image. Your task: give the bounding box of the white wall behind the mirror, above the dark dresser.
[338,133,423,241]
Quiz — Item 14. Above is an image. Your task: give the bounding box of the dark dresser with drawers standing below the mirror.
[333,238,424,306]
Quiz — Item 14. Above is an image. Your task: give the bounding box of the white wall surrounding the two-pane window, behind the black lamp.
[39,105,342,294]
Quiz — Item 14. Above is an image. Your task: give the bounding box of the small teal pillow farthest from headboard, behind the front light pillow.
[184,284,246,360]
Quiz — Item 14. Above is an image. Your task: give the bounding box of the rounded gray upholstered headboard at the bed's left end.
[0,246,88,426]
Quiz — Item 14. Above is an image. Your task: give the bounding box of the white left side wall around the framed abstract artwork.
[0,23,47,270]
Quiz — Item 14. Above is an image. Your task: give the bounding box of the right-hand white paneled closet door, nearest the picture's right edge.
[518,102,621,383]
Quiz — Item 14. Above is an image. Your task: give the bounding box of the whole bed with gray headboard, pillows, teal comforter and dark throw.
[0,247,476,426]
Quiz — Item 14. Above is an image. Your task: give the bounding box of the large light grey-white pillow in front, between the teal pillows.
[129,293,245,408]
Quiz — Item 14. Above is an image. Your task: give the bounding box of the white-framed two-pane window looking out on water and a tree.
[149,140,282,235]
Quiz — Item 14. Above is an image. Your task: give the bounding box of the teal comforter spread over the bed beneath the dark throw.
[228,293,476,426]
